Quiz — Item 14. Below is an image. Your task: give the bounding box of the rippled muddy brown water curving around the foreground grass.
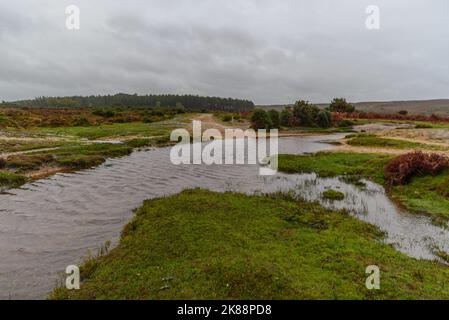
[0,134,449,299]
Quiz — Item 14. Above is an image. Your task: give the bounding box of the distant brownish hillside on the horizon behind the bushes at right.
[257,99,449,116]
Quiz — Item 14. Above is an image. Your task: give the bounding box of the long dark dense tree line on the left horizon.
[10,93,254,111]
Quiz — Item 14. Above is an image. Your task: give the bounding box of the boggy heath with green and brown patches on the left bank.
[0,109,196,191]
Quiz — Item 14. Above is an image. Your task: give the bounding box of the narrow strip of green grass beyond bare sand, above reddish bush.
[347,134,447,151]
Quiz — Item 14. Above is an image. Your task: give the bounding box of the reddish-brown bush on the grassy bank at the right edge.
[385,151,449,185]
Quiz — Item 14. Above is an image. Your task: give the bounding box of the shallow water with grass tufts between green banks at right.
[256,173,449,259]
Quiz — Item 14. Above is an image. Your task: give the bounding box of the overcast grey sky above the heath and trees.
[0,0,449,104]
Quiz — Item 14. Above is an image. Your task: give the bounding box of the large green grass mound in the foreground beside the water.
[51,189,449,299]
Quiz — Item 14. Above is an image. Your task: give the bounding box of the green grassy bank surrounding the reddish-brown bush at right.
[279,152,449,223]
